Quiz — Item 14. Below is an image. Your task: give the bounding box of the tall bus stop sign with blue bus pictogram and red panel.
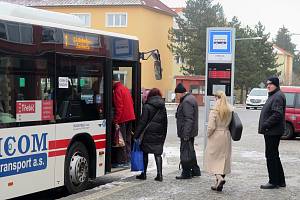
[204,27,235,150]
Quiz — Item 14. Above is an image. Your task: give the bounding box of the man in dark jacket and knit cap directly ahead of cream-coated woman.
[175,83,201,179]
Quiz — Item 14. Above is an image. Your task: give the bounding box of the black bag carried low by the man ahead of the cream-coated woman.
[180,140,196,168]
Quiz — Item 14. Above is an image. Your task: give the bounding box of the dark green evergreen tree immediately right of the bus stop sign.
[229,17,278,102]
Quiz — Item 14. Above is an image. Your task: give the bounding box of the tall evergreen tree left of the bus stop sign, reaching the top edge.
[168,0,225,75]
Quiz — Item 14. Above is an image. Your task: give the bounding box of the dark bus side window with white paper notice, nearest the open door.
[55,54,104,123]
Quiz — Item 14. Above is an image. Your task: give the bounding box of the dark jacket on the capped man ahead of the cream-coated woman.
[176,93,198,138]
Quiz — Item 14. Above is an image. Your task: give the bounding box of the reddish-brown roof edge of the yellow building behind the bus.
[0,0,176,16]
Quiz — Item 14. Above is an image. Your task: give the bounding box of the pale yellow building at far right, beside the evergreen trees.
[273,45,293,85]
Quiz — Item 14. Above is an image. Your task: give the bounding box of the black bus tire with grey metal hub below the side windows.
[64,142,89,194]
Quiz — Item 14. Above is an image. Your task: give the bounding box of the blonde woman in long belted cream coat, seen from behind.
[204,91,232,191]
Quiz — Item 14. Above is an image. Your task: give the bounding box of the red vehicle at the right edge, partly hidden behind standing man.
[280,86,300,139]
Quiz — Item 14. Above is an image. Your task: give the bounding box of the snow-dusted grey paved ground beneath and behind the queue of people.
[14,107,300,200]
